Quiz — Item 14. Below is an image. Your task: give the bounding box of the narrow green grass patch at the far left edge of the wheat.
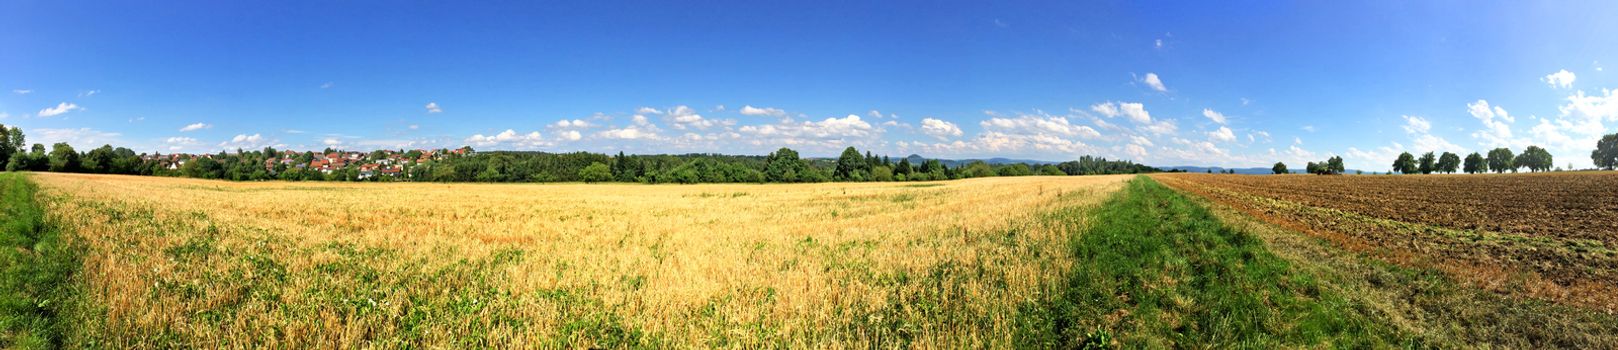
[0,173,79,348]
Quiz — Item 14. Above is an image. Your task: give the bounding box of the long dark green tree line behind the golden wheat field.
[0,125,1160,183]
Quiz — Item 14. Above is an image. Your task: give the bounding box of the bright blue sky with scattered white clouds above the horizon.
[0,0,1618,170]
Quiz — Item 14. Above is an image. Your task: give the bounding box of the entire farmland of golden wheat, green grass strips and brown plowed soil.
[12,173,1618,348]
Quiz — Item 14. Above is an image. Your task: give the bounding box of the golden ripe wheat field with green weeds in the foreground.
[32,173,1129,348]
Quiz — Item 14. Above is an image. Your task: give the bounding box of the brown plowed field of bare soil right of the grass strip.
[1155,172,1618,313]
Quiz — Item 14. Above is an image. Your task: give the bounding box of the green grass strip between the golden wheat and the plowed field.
[1018,177,1413,348]
